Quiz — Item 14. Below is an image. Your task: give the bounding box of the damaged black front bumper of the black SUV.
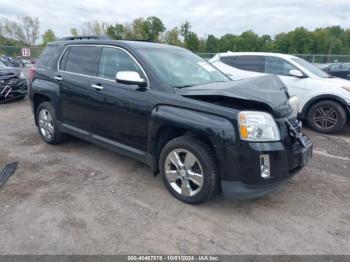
[219,118,313,199]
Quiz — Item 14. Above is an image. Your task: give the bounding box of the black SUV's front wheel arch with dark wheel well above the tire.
[148,106,236,174]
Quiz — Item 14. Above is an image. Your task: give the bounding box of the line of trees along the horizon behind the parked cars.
[0,16,350,55]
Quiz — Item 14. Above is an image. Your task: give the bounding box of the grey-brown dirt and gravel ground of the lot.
[0,97,350,254]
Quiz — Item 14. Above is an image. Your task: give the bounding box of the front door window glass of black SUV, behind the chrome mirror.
[98,47,143,80]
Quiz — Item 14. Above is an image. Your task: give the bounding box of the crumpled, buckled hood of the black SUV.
[178,75,293,118]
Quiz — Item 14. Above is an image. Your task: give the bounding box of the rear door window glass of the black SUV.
[65,46,99,76]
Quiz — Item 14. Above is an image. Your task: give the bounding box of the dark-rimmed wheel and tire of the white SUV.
[307,100,347,134]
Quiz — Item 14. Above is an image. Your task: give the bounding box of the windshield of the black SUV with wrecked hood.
[139,48,230,88]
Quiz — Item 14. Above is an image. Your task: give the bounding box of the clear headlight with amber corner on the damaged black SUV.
[238,111,281,141]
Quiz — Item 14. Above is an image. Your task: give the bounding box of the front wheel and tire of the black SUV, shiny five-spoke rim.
[159,136,219,204]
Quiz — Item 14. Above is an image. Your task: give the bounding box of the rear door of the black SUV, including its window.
[57,46,100,131]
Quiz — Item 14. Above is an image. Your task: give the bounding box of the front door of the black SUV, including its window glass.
[87,47,153,151]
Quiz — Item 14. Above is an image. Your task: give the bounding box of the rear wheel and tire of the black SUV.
[36,102,66,145]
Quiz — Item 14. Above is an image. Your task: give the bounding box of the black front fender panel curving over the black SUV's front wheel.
[147,105,237,170]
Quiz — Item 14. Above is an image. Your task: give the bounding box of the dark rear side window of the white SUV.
[231,56,265,73]
